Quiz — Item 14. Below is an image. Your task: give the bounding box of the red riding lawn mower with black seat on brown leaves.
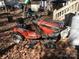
[12,17,63,48]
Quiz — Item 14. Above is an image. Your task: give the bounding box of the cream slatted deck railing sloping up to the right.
[53,1,79,20]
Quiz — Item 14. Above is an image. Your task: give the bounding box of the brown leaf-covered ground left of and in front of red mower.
[0,11,76,59]
